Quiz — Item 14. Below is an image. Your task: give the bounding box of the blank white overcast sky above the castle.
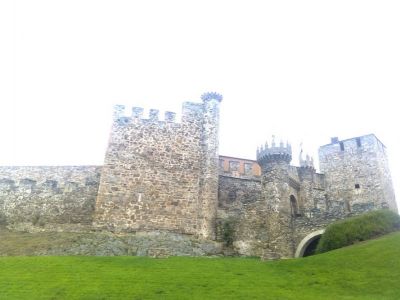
[0,0,400,206]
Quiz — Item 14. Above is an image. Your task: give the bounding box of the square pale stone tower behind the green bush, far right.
[319,134,397,212]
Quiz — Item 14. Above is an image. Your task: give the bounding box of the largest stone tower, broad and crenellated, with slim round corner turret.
[95,93,222,238]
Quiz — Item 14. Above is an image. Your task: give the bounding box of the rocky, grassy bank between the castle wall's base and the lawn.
[0,227,223,257]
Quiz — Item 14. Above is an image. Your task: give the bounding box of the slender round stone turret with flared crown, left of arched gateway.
[257,137,297,258]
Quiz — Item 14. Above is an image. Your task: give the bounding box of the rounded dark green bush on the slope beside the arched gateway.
[316,209,400,253]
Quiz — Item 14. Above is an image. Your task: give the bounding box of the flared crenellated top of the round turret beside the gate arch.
[257,136,292,165]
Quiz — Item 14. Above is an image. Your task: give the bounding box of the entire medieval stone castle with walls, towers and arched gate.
[0,93,397,259]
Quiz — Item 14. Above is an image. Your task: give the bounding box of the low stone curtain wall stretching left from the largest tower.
[0,166,101,227]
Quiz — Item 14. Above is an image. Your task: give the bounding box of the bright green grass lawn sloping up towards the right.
[0,233,400,299]
